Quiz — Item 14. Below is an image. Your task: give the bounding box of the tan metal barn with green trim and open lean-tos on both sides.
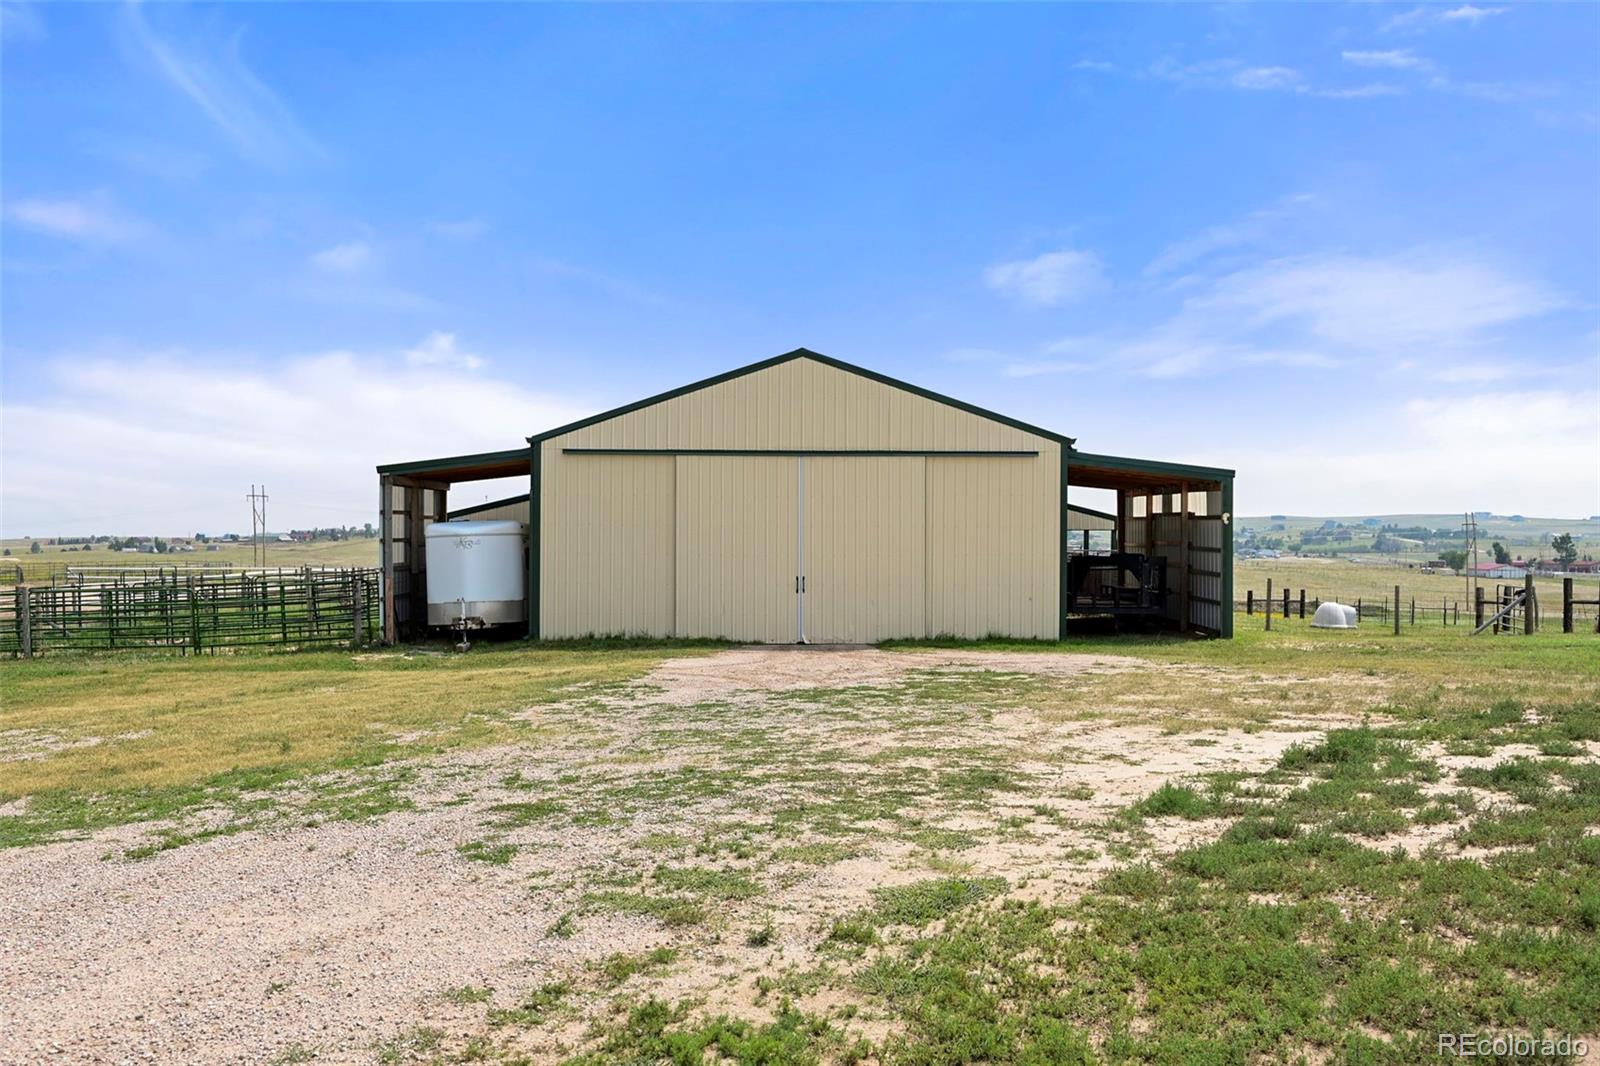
[378,349,1234,643]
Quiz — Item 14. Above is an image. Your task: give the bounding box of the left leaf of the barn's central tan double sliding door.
[675,455,800,643]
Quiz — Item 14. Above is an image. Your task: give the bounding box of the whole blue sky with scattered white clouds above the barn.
[0,3,1600,536]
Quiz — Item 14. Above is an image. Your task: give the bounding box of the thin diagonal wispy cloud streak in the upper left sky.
[125,3,322,168]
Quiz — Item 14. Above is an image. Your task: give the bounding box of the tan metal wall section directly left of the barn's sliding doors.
[540,455,674,637]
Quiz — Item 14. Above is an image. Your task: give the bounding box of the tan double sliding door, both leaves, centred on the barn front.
[674,455,926,633]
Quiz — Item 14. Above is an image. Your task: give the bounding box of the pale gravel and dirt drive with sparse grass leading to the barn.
[0,648,1342,1063]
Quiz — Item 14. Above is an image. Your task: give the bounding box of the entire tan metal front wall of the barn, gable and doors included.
[539,359,1061,642]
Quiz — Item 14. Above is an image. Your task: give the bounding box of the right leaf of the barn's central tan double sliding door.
[802,456,928,643]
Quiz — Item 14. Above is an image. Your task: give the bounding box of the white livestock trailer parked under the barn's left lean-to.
[422,522,528,627]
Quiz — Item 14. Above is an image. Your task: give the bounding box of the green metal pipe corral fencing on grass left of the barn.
[0,568,379,658]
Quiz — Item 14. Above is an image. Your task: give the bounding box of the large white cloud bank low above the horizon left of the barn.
[0,335,594,535]
